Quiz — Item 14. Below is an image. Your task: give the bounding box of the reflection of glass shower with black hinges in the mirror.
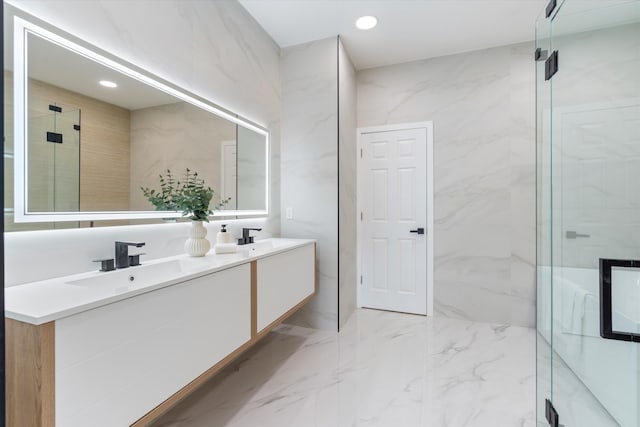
[28,102,80,212]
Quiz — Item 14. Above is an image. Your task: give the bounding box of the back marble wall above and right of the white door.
[357,43,535,326]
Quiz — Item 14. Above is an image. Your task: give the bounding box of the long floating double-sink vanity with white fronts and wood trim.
[5,239,316,427]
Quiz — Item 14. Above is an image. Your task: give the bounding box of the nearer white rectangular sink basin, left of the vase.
[65,260,185,288]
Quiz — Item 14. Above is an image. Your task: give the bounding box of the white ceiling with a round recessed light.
[239,0,548,69]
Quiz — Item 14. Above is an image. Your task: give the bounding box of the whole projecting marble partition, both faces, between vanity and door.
[281,37,357,330]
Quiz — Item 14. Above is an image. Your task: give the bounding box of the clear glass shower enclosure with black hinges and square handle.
[536,0,640,427]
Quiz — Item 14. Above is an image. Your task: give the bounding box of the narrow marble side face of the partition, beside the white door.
[338,40,357,329]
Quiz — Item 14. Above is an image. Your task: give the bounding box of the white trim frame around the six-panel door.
[356,121,434,316]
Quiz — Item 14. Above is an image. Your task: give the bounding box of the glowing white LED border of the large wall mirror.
[13,16,270,223]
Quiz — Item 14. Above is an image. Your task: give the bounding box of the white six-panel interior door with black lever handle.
[358,124,433,314]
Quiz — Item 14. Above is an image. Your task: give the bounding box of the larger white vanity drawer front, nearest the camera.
[55,264,251,427]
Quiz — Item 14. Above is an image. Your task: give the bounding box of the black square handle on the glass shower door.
[600,258,640,342]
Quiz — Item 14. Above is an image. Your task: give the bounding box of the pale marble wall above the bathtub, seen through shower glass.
[545,21,640,268]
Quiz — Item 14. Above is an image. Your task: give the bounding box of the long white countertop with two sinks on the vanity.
[5,239,315,325]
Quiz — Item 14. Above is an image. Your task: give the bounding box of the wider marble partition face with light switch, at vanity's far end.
[281,37,339,330]
